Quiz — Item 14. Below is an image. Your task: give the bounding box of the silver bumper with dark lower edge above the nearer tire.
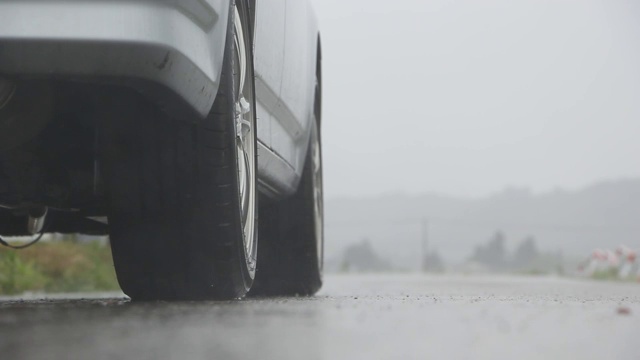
[0,0,230,117]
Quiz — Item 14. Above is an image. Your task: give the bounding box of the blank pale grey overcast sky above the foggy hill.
[313,0,640,198]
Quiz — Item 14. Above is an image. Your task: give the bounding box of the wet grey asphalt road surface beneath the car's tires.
[0,275,640,360]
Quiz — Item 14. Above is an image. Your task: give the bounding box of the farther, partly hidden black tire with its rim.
[250,116,324,296]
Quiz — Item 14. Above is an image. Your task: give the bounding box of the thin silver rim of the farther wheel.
[311,122,324,274]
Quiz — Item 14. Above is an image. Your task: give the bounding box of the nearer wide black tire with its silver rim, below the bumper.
[100,2,258,300]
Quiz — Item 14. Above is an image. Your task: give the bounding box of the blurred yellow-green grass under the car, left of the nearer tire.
[0,236,119,295]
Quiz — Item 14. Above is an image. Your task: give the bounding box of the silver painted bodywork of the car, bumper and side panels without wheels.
[0,0,320,202]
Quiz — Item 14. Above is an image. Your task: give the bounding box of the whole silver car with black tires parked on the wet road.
[0,0,323,300]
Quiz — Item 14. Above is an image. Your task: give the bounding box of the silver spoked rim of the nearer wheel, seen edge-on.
[234,6,257,271]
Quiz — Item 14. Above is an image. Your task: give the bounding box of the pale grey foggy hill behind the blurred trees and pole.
[325,179,640,268]
